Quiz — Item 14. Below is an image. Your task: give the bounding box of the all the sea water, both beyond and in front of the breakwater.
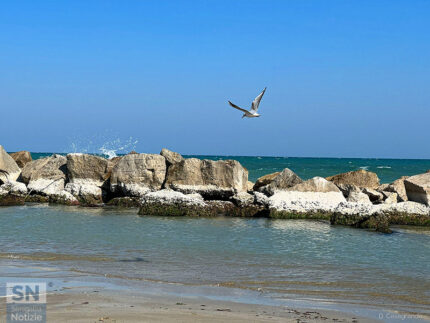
[0,153,430,322]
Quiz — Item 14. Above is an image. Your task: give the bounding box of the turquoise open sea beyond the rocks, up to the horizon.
[32,153,430,183]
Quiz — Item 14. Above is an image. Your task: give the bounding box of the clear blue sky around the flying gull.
[0,0,430,159]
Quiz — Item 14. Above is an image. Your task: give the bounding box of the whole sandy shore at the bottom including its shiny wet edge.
[0,264,422,323]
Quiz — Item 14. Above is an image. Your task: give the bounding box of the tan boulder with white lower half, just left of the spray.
[20,154,67,195]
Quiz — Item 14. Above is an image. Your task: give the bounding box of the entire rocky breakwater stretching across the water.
[0,146,430,232]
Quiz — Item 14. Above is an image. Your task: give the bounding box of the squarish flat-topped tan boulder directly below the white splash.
[67,153,113,187]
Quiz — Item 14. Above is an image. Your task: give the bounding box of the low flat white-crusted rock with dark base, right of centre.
[267,191,346,218]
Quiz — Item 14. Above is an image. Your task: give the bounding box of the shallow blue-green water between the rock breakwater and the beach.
[0,205,430,314]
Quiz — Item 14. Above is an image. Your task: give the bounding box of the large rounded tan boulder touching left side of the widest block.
[110,154,166,197]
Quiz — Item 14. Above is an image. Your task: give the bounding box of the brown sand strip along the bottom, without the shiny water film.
[0,289,376,323]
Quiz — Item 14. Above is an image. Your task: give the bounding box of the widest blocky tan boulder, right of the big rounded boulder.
[165,158,248,200]
